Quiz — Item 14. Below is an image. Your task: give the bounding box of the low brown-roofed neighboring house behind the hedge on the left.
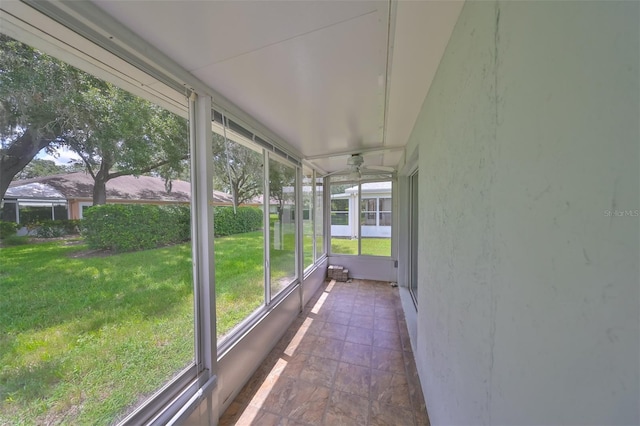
[0,172,233,223]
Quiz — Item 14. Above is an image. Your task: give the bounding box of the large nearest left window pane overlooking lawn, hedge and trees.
[0,35,196,424]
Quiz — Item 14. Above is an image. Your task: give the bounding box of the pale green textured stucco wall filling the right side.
[409,2,640,424]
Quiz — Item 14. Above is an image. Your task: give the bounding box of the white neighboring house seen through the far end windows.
[331,182,392,238]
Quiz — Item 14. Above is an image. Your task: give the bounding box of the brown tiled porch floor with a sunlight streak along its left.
[220,280,429,426]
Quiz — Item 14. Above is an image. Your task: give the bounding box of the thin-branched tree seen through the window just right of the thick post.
[213,133,263,207]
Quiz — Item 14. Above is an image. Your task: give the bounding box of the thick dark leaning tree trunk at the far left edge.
[0,129,51,200]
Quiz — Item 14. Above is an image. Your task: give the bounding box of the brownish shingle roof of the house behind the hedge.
[5,172,233,204]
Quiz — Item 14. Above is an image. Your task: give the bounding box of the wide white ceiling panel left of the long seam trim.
[90,0,389,161]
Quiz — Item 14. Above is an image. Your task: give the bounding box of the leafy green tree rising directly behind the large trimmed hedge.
[68,83,189,205]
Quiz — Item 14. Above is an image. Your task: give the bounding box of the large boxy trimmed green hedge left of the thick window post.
[82,204,190,251]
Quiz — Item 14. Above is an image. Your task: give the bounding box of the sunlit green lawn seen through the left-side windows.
[0,231,302,425]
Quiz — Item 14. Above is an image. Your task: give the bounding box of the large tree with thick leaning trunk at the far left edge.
[0,34,90,199]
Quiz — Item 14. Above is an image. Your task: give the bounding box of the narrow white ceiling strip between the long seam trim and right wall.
[385,0,464,149]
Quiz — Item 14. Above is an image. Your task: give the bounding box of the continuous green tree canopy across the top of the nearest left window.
[0,34,189,204]
